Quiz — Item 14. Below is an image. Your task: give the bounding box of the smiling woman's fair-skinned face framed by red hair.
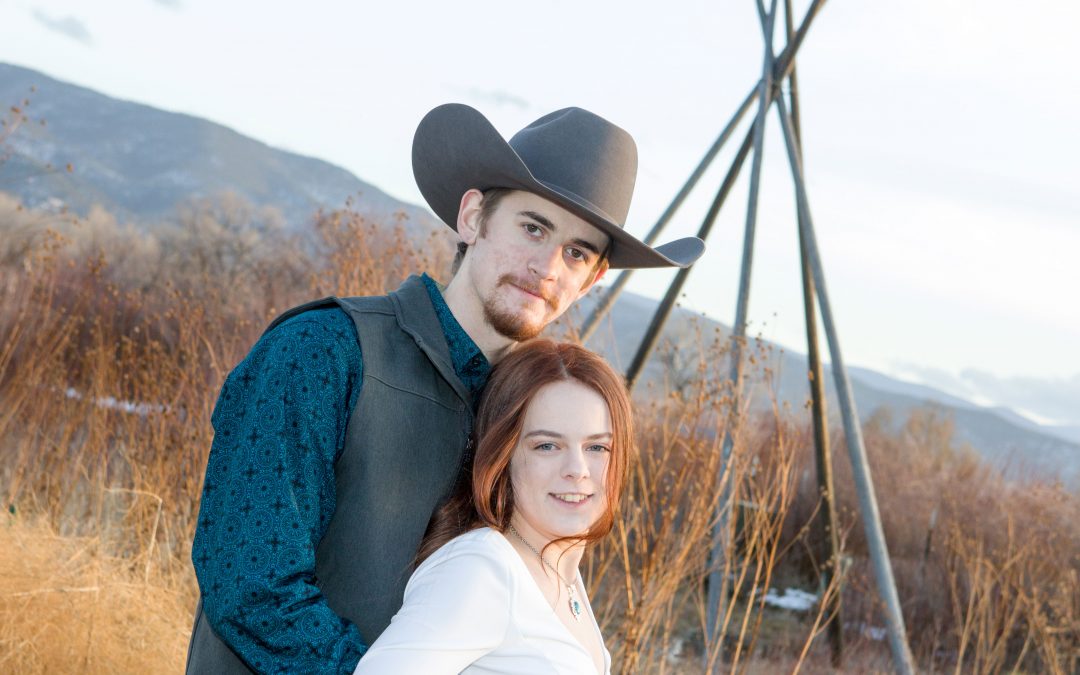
[510,380,611,542]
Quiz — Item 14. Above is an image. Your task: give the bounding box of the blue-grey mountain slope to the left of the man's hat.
[0,63,438,231]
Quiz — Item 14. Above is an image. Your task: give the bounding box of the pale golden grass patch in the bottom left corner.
[0,517,193,673]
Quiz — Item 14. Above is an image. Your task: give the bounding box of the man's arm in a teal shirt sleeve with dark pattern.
[191,308,366,673]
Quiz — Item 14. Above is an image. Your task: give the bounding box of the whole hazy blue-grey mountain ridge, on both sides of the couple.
[0,63,1080,485]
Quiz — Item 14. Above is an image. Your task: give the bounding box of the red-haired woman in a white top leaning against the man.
[355,340,633,675]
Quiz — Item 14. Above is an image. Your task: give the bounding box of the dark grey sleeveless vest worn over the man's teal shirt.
[187,276,472,675]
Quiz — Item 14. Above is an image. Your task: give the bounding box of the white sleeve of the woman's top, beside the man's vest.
[354,537,512,675]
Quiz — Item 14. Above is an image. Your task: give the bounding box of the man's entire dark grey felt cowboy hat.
[413,104,705,268]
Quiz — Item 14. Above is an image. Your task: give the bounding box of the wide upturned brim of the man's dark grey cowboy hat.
[413,104,705,268]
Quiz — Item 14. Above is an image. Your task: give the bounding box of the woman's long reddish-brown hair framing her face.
[417,339,634,564]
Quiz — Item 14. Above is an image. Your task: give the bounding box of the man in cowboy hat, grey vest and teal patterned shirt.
[188,105,704,674]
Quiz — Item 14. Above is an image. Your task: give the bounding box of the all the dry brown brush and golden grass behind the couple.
[0,195,1080,673]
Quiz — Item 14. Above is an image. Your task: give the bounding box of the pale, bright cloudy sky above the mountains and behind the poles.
[0,0,1080,426]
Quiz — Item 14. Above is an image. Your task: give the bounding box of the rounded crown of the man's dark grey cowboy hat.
[510,108,637,226]
